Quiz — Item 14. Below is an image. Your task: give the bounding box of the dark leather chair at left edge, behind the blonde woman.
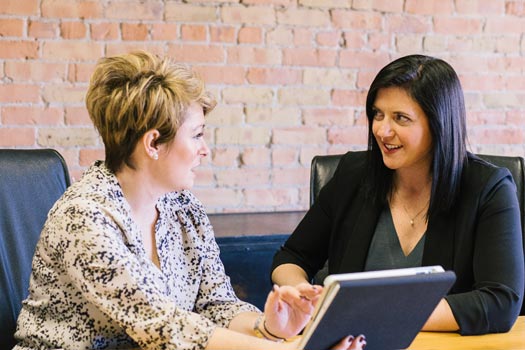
[0,149,70,349]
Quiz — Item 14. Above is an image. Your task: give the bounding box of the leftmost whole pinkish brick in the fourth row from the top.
[5,60,67,82]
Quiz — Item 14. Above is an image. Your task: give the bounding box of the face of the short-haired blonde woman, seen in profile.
[159,103,210,191]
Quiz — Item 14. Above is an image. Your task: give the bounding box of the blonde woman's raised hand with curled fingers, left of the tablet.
[263,283,321,338]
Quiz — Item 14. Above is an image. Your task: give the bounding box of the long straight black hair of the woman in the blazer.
[365,55,467,218]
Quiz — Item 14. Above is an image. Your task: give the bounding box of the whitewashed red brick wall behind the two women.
[0,0,525,212]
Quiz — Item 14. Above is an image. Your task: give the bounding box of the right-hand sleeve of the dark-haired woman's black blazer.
[446,169,524,335]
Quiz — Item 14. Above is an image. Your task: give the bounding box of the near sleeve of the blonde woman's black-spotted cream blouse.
[48,200,216,349]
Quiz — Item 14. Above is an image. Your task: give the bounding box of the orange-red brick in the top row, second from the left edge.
[42,0,104,19]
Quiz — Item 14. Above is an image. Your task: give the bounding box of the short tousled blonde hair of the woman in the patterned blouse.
[86,51,216,173]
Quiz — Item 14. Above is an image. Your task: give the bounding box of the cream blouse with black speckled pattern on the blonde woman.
[15,161,259,349]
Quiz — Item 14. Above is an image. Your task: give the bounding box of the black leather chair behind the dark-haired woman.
[310,151,525,315]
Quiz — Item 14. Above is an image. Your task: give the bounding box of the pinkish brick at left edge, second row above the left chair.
[2,106,63,125]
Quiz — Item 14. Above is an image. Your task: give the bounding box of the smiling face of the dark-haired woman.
[372,87,432,171]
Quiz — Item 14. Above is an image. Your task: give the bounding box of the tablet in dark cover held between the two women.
[299,266,456,350]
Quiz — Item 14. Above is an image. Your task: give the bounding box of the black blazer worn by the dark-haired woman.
[272,152,524,334]
